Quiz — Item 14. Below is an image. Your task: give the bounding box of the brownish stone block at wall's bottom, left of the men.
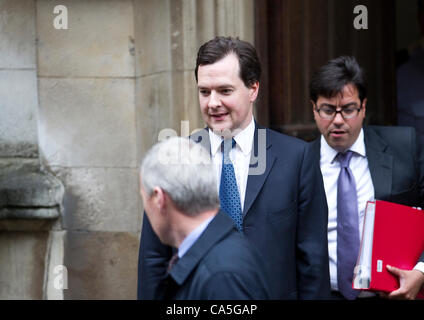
[64,231,139,299]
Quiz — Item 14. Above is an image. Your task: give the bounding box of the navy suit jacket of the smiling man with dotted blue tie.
[138,126,330,299]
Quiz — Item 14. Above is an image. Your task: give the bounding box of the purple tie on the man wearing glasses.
[337,150,359,300]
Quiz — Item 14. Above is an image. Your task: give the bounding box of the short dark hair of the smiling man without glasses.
[194,37,261,88]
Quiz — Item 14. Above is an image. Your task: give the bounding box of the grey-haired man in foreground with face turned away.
[140,137,269,300]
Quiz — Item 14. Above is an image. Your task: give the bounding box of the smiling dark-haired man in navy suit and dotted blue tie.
[138,37,330,299]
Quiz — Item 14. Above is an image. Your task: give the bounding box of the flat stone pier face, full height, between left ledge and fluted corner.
[36,0,142,299]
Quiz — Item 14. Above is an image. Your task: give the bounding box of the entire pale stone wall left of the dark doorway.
[0,0,254,299]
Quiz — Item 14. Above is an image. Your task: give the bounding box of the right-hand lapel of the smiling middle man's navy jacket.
[243,126,276,217]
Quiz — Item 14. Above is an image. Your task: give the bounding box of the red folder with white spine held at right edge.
[352,200,424,298]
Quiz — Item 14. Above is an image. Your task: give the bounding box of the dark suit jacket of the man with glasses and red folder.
[311,126,424,262]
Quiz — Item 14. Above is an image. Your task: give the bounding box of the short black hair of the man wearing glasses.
[309,56,367,103]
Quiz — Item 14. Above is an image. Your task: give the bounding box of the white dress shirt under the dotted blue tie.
[209,117,255,211]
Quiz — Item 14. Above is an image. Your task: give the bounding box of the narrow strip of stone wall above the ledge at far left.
[0,0,38,158]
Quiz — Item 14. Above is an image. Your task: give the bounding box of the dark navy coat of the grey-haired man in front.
[156,211,269,300]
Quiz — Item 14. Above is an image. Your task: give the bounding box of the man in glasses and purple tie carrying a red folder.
[310,56,424,299]
